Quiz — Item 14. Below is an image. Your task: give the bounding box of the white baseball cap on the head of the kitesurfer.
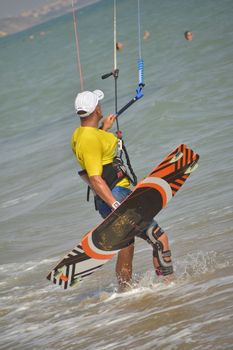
[74,90,104,118]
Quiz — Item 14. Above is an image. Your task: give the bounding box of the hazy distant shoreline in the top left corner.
[0,0,101,38]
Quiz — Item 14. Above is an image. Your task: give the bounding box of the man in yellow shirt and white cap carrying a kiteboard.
[71,90,173,289]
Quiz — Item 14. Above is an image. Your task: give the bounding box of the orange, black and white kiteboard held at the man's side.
[47,144,199,289]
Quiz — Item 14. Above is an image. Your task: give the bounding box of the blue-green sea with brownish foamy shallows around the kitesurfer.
[0,0,233,350]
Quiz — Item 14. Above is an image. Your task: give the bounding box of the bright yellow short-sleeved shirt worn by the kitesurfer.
[71,126,130,188]
